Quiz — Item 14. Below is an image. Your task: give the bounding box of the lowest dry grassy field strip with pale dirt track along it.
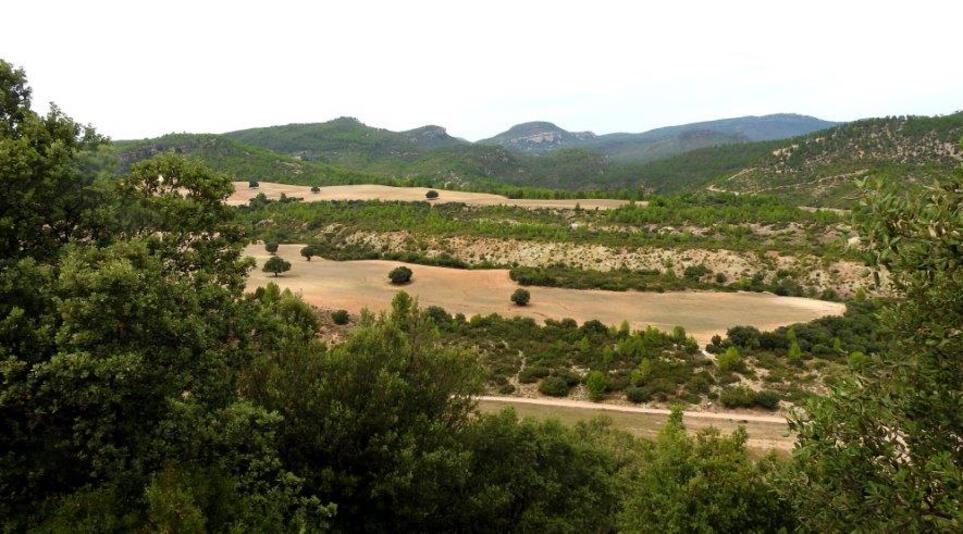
[478,397,795,452]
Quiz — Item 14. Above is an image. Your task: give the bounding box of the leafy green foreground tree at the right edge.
[787,165,963,532]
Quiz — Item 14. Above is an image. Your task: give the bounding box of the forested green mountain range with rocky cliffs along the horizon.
[113,112,963,206]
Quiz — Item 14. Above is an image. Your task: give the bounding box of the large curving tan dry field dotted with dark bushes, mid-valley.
[246,245,846,344]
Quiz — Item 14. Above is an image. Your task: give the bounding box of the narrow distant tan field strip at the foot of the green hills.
[227,182,628,209]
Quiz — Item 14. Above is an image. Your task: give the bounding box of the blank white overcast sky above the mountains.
[0,0,963,140]
